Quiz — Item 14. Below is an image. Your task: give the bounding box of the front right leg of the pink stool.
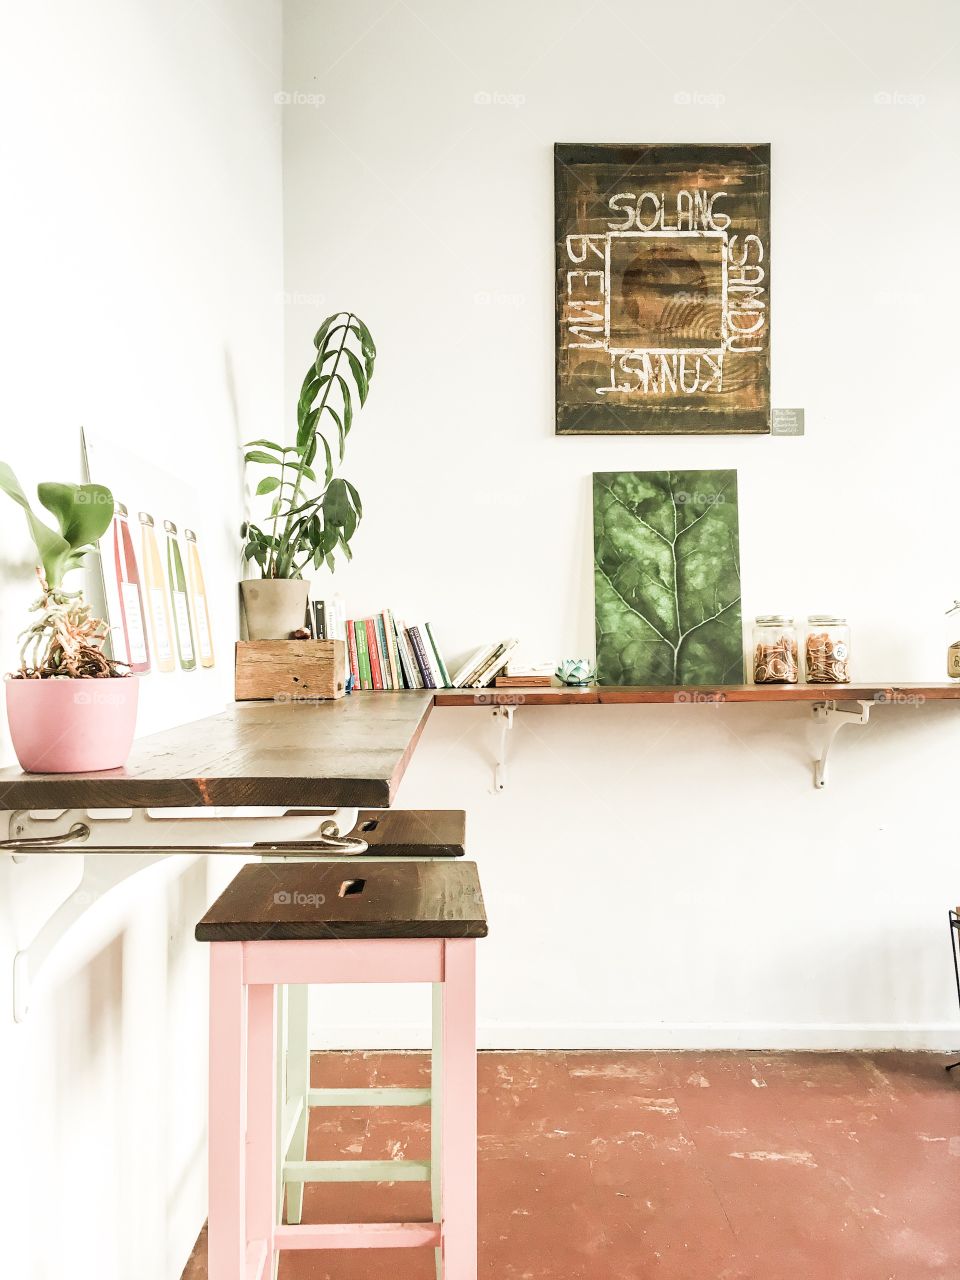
[440,938,477,1280]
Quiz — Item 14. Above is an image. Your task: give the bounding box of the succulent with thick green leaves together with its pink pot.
[0,462,138,773]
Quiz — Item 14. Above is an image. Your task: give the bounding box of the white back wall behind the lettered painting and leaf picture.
[284,0,960,1047]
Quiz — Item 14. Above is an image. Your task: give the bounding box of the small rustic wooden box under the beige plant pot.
[234,640,347,703]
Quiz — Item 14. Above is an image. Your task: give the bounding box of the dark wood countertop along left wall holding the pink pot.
[0,690,434,809]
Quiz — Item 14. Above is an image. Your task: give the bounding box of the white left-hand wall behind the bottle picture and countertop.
[0,0,283,1280]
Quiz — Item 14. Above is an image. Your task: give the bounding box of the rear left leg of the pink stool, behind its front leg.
[246,986,276,1280]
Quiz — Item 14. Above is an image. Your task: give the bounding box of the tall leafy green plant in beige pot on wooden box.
[241,311,376,640]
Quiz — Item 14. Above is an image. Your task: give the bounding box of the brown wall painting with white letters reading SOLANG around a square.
[554,143,771,435]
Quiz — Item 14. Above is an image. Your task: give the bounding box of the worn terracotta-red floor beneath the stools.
[184,1052,960,1280]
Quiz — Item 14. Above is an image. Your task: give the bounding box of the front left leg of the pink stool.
[207,942,247,1280]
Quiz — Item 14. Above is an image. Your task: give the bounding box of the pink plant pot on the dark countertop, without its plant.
[6,676,140,773]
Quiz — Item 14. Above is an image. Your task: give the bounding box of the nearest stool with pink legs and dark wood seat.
[196,860,486,1280]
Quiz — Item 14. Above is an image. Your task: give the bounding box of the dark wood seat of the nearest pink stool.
[196,860,486,942]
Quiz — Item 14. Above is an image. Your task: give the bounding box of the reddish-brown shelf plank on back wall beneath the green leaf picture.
[435,680,960,707]
